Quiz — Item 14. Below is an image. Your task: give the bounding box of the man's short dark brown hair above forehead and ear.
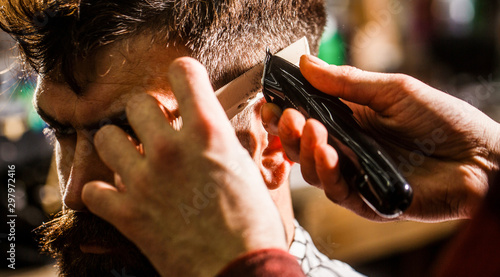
[0,0,325,93]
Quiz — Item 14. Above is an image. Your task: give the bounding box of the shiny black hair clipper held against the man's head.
[262,51,413,218]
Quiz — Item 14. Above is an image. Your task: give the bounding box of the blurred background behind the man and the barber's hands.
[0,0,500,276]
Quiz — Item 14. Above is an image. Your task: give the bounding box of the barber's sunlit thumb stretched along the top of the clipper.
[300,55,409,112]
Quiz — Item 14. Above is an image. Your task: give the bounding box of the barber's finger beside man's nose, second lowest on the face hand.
[94,125,142,178]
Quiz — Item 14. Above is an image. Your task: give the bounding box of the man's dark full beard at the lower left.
[36,210,159,277]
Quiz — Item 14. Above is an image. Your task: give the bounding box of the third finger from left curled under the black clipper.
[300,119,328,186]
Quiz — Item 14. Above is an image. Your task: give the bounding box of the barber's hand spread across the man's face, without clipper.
[82,58,286,276]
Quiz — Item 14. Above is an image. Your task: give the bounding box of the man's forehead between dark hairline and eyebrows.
[34,36,185,126]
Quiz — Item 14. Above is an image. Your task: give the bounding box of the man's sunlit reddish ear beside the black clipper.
[251,101,293,190]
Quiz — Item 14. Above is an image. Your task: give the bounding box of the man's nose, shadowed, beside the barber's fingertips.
[63,135,114,211]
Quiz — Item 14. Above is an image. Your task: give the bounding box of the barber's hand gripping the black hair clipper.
[262,56,500,221]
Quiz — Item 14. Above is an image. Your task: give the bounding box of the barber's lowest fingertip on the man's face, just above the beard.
[82,181,127,226]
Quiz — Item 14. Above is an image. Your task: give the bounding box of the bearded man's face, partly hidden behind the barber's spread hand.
[34,39,186,277]
